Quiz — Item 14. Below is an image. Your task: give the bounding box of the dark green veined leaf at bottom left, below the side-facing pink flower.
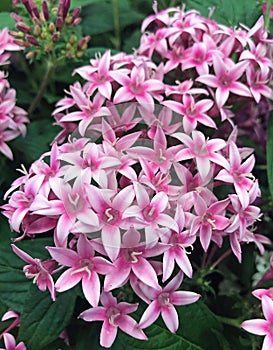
[18,287,76,350]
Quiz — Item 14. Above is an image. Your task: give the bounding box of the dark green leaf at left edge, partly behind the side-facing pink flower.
[0,238,52,312]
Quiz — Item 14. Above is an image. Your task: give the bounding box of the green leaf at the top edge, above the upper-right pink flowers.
[185,0,262,26]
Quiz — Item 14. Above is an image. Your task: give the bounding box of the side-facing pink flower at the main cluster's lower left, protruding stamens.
[11,244,57,300]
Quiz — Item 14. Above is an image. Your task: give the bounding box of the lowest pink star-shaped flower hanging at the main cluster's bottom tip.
[79,292,147,348]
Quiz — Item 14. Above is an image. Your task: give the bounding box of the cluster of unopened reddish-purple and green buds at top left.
[11,0,90,60]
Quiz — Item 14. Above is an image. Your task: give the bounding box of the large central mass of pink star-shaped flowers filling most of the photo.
[2,4,272,347]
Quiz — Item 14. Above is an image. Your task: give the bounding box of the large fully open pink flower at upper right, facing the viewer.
[196,55,250,108]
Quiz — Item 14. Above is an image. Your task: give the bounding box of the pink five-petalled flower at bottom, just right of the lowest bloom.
[139,272,200,333]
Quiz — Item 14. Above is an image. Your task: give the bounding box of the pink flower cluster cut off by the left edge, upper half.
[0,28,28,159]
